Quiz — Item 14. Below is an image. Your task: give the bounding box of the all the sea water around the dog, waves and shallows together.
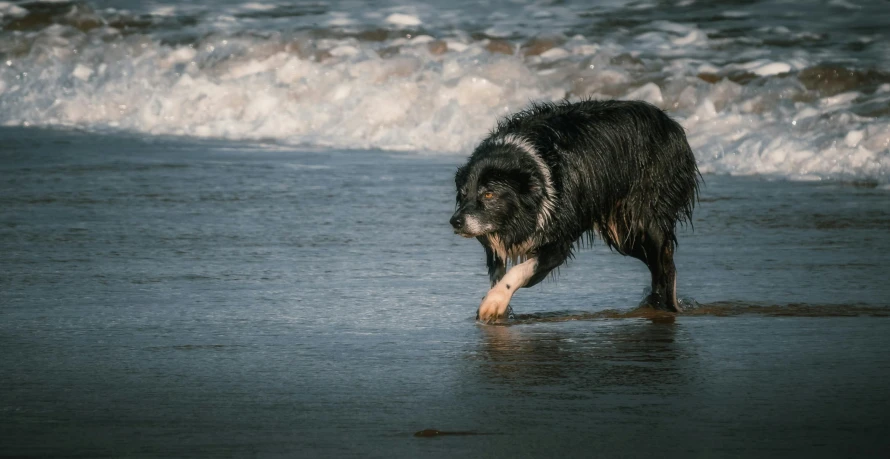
[0,0,890,457]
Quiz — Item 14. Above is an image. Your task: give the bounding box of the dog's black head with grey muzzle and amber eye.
[451,145,545,241]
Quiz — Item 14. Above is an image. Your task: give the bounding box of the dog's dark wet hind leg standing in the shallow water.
[626,229,680,312]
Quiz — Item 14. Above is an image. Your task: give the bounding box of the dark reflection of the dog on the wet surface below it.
[474,314,694,394]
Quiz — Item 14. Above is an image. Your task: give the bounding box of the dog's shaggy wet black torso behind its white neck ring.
[490,101,699,252]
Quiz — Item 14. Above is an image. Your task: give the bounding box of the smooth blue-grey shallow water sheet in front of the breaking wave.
[0,128,890,457]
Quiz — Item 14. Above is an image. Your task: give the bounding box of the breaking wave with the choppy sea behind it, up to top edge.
[0,1,890,184]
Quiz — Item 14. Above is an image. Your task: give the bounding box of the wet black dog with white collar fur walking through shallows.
[451,101,700,322]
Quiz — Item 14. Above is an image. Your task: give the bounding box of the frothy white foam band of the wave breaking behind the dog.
[0,3,890,183]
